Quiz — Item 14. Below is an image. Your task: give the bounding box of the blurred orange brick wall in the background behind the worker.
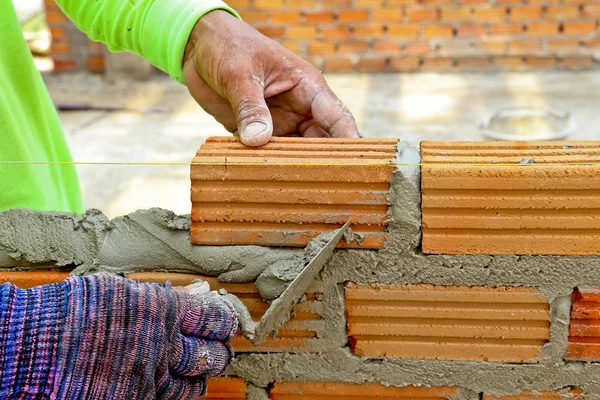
[46,0,600,72]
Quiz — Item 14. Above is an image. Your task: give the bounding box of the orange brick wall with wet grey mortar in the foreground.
[5,138,600,400]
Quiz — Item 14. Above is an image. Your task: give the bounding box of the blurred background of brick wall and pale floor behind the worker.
[15,0,600,217]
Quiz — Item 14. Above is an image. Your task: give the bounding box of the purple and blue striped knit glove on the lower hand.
[0,274,238,400]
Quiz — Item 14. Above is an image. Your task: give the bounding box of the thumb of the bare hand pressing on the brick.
[231,82,273,146]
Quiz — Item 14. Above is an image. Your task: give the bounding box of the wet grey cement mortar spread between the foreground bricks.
[0,143,600,400]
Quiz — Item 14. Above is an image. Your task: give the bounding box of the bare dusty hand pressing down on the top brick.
[183,10,360,146]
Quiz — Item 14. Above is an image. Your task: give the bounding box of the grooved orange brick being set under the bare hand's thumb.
[190,137,398,249]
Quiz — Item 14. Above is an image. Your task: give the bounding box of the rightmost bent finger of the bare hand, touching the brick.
[310,87,360,138]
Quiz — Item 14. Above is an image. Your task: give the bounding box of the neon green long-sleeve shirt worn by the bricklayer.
[0,0,238,213]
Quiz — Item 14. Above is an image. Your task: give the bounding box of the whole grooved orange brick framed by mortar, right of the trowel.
[346,283,550,363]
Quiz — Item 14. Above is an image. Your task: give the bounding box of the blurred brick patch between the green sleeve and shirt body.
[44,0,107,73]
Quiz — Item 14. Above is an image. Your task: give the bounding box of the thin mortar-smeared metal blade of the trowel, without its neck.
[252,221,351,345]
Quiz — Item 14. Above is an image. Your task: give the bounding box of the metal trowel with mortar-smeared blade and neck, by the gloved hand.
[222,221,350,346]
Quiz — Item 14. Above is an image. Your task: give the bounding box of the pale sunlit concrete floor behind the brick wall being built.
[45,72,600,217]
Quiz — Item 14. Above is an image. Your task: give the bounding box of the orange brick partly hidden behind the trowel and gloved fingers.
[127,272,324,352]
